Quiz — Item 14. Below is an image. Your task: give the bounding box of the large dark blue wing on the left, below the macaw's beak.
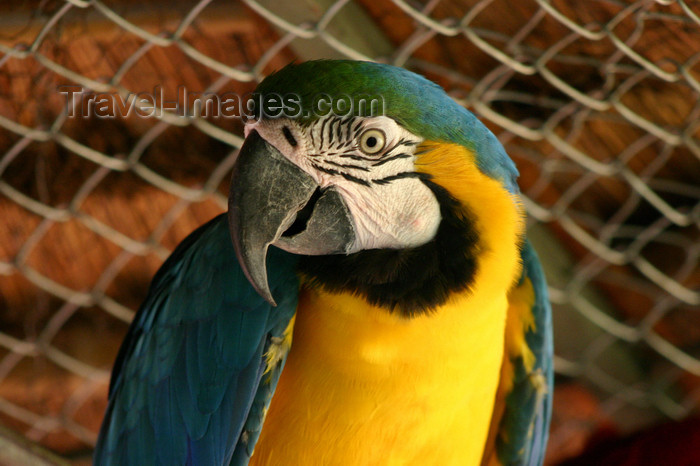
[94,215,299,466]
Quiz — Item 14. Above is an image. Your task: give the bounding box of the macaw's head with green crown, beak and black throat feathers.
[229,60,523,315]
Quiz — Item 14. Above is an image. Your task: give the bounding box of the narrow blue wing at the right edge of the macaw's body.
[496,241,554,466]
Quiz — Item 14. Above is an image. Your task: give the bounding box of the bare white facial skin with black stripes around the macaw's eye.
[245,116,441,252]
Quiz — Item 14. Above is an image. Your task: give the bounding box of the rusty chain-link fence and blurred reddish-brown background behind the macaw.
[0,0,700,464]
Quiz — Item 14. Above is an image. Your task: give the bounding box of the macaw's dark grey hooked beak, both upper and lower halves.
[228,130,355,305]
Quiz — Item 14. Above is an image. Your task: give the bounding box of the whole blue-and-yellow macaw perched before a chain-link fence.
[94,60,552,466]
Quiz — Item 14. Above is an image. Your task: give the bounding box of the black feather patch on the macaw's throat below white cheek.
[299,179,482,317]
